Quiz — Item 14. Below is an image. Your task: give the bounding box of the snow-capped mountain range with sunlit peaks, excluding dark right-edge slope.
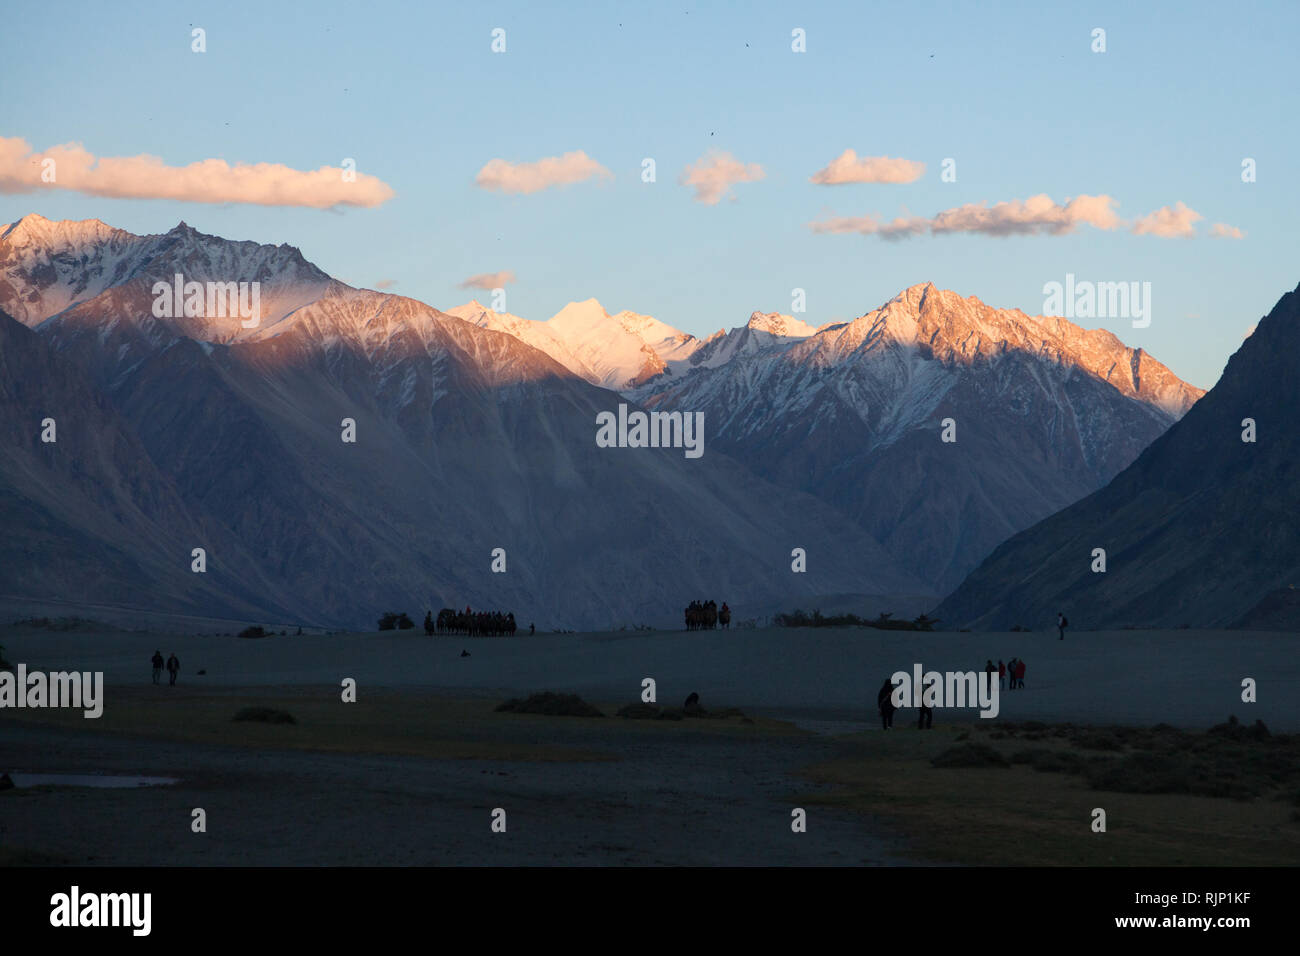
[0,215,1201,627]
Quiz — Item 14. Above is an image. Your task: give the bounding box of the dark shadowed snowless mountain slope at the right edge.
[936,280,1300,630]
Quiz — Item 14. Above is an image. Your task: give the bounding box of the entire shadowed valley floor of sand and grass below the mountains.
[0,631,1300,866]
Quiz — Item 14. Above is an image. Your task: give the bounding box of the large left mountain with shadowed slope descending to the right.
[0,215,926,627]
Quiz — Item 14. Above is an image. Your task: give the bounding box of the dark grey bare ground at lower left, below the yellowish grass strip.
[0,718,897,866]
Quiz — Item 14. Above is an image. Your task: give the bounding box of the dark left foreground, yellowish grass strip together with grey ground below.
[0,688,902,866]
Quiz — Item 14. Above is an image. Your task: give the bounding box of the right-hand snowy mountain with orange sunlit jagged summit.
[629,284,1201,591]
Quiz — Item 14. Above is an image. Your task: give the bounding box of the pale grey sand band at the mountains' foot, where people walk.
[0,628,1300,732]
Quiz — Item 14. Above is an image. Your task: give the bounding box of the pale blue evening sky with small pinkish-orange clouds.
[0,0,1300,388]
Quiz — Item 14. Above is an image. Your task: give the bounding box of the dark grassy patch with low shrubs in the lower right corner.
[798,724,1300,866]
